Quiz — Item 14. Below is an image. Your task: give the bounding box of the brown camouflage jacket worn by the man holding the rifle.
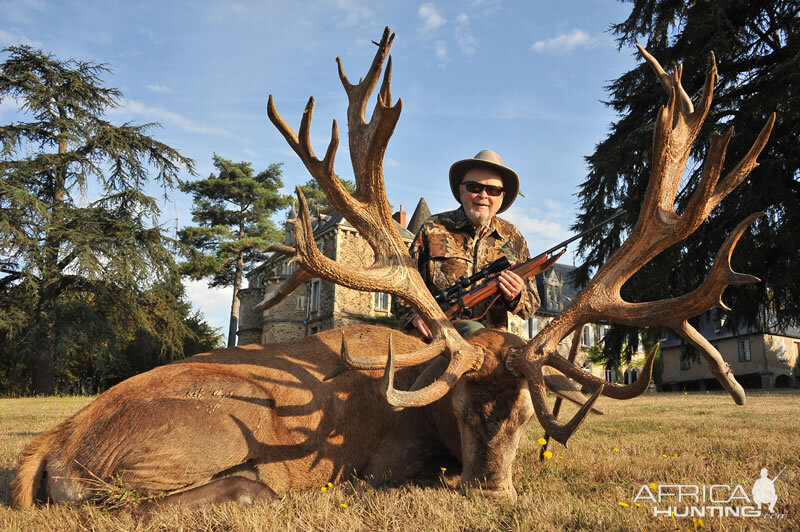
[399,207,541,329]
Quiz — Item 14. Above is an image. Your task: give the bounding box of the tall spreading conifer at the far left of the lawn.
[0,46,200,394]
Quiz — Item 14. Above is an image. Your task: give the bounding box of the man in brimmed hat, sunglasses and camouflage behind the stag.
[407,150,540,338]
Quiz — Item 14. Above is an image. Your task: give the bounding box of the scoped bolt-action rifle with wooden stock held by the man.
[434,209,624,320]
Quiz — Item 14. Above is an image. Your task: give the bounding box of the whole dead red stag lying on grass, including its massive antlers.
[12,28,774,507]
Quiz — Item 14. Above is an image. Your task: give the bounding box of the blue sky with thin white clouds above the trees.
[0,0,640,331]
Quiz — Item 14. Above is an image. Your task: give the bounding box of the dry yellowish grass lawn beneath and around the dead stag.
[0,391,800,531]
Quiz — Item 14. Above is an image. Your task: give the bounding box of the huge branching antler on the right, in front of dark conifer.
[508,47,775,445]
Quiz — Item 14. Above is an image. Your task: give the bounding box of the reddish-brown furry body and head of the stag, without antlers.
[12,325,582,507]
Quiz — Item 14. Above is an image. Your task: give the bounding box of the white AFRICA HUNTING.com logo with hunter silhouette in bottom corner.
[633,467,786,519]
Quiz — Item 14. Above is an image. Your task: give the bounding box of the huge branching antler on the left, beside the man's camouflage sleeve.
[266,27,483,407]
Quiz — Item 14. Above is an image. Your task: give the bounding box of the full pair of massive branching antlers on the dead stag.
[256,27,775,445]
